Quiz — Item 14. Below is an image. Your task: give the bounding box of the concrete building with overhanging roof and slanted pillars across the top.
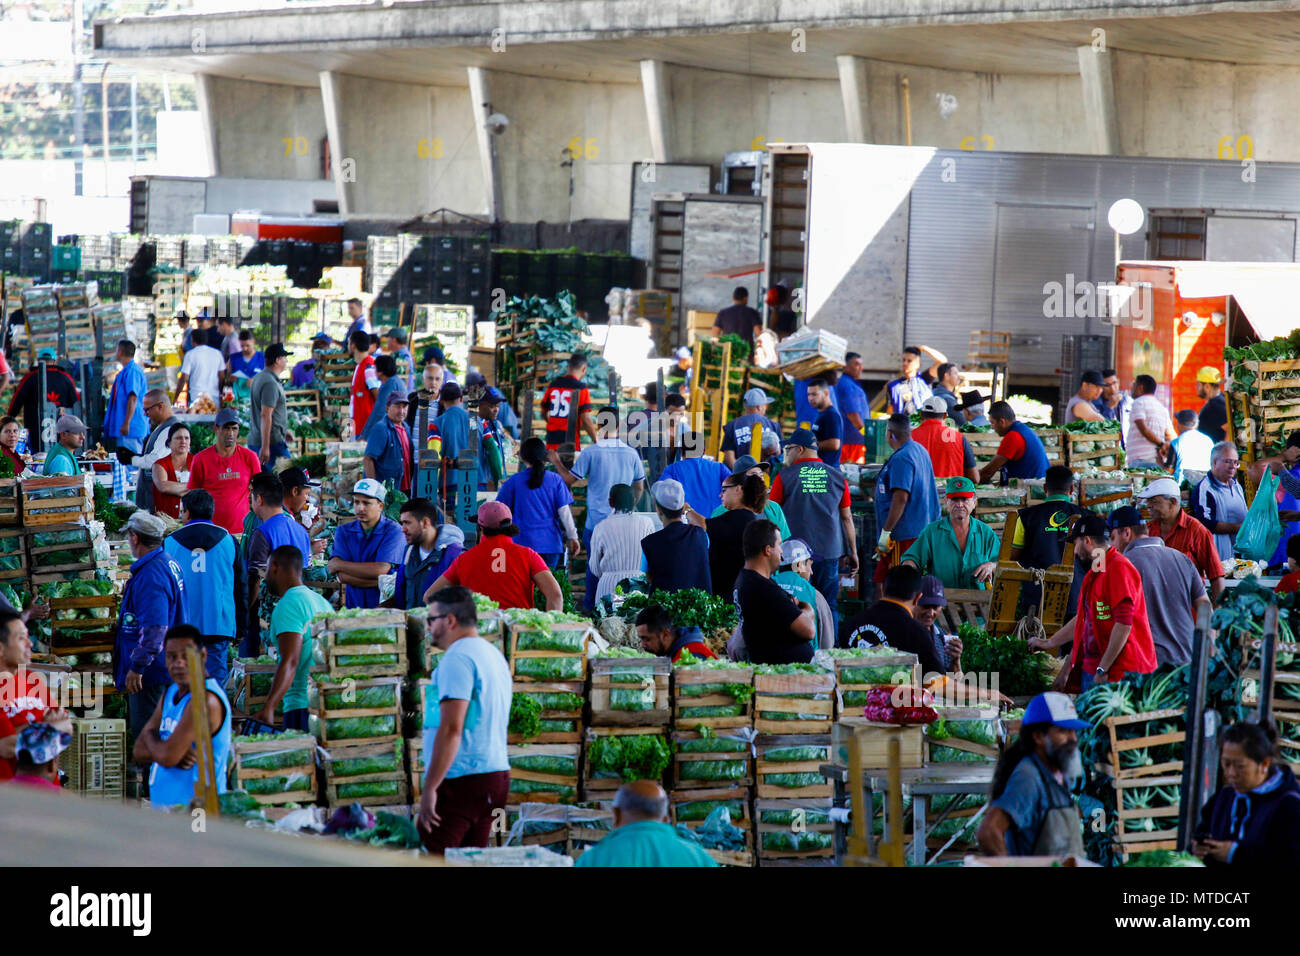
[95,0,1300,221]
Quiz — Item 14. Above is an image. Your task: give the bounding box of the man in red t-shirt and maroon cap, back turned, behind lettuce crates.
[424,501,564,611]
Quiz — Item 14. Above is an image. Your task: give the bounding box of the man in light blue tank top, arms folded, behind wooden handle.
[133,624,230,809]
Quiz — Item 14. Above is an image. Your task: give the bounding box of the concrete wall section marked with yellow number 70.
[209,77,325,179]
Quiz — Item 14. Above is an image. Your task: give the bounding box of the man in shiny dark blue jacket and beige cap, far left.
[113,511,189,737]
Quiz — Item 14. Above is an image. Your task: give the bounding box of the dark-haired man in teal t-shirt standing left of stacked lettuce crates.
[254,545,334,731]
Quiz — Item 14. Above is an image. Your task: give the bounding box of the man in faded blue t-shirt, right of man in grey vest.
[875,415,940,583]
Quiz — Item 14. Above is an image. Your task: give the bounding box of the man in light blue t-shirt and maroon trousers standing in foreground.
[416,587,512,853]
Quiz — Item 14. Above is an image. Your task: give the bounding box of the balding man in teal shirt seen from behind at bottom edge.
[575,780,718,866]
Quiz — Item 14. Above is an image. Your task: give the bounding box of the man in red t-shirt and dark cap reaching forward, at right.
[1030,514,1156,692]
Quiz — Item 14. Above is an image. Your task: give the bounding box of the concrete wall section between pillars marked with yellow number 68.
[330,74,488,216]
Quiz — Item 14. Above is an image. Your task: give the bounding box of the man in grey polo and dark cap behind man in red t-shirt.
[1108,505,1210,667]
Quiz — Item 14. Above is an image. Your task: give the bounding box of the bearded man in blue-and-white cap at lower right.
[976,692,1089,858]
